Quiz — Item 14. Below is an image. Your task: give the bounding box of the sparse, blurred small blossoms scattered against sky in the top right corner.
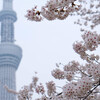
[75,0,100,29]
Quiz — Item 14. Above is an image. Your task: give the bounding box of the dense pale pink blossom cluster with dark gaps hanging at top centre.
[26,0,81,21]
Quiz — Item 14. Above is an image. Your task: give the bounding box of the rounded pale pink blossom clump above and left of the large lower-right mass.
[51,60,79,81]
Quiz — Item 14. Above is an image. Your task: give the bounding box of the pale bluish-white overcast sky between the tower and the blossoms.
[0,0,99,98]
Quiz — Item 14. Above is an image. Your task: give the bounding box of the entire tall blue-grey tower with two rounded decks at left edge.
[0,0,22,100]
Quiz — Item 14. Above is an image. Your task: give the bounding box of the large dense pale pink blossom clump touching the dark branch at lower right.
[63,77,92,99]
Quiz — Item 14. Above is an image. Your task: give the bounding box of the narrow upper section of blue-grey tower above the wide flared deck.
[0,0,17,43]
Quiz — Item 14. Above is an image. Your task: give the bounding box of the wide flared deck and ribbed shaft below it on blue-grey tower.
[0,43,22,100]
